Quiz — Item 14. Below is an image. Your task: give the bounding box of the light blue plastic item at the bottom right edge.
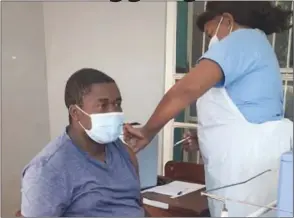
[277,151,293,217]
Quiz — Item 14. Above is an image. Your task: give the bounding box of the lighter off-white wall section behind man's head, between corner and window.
[44,2,166,138]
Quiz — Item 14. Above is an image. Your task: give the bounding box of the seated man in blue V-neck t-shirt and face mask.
[21,69,144,217]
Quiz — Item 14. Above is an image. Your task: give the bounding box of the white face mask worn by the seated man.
[76,105,124,144]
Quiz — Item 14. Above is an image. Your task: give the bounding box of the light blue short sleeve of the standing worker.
[199,33,254,87]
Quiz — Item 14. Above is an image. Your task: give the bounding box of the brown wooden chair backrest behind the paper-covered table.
[164,161,205,184]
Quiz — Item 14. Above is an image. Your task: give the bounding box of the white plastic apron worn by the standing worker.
[197,88,293,217]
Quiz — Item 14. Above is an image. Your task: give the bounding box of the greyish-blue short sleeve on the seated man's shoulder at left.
[21,166,68,217]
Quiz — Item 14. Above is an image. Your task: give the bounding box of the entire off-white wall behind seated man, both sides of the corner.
[1,2,166,217]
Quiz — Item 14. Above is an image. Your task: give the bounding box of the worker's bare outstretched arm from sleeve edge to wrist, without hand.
[144,59,223,138]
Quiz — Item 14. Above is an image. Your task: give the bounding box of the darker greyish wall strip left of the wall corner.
[1,2,50,217]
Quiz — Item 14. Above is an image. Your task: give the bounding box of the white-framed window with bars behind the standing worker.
[163,1,293,166]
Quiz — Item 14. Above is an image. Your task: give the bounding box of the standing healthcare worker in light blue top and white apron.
[124,1,293,217]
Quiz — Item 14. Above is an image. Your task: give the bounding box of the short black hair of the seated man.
[64,68,115,109]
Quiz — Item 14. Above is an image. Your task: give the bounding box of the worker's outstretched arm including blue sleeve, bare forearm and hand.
[124,37,247,152]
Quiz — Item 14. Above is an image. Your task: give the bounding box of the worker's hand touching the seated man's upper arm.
[124,124,153,153]
